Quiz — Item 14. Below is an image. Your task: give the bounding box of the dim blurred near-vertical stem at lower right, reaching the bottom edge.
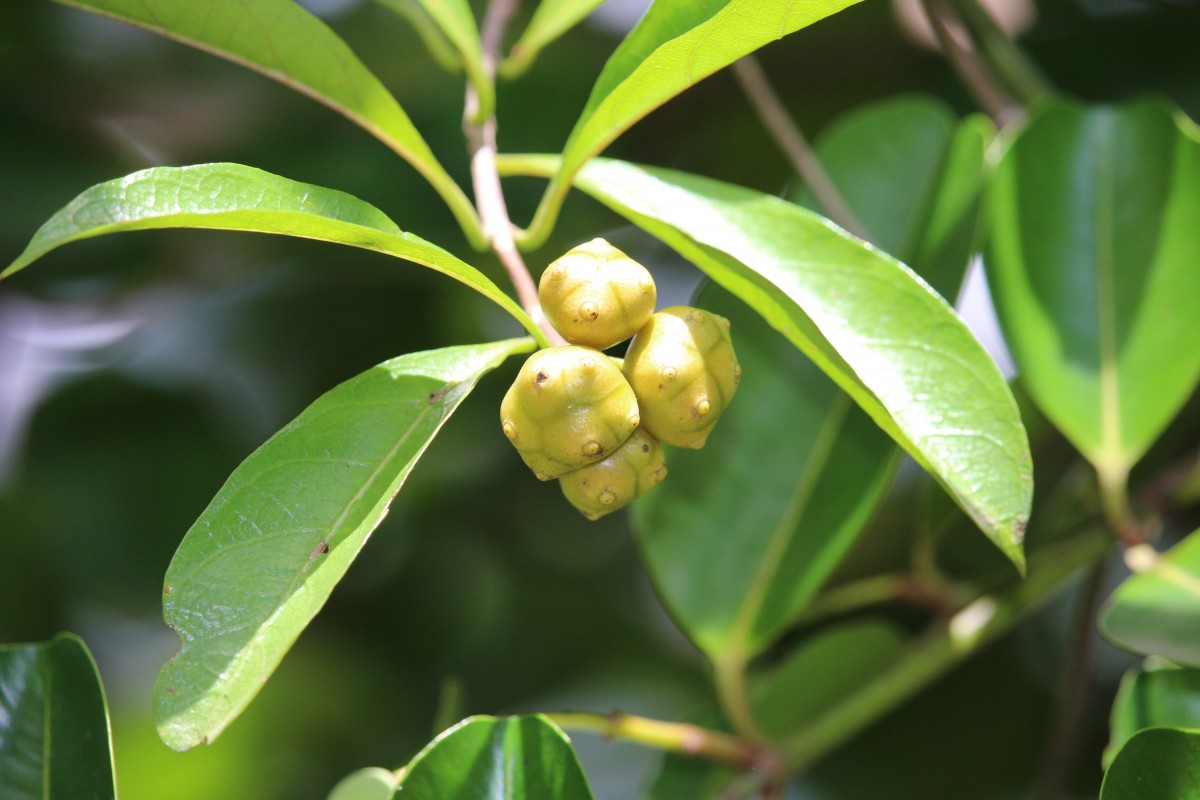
[1033,561,1106,800]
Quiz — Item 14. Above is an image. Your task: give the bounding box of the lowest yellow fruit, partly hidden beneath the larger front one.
[558,429,667,519]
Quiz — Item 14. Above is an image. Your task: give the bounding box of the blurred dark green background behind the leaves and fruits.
[0,0,1200,800]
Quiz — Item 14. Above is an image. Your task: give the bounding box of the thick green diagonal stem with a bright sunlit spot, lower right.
[780,529,1112,774]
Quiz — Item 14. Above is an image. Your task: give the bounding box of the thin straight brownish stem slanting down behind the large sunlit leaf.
[733,55,870,239]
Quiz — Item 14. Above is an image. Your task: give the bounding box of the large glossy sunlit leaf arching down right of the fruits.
[504,156,1033,569]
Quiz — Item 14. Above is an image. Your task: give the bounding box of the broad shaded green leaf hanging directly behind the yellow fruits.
[634,284,898,657]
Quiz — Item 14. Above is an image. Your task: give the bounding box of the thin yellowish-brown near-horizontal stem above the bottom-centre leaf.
[546,711,766,770]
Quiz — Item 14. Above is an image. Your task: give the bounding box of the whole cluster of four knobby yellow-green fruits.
[500,239,742,519]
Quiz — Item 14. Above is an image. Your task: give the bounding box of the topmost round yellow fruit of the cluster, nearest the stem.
[538,239,658,350]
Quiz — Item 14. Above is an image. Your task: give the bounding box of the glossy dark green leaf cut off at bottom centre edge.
[395,716,593,800]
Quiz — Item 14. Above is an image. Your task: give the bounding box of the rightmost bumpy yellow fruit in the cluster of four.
[624,306,742,447]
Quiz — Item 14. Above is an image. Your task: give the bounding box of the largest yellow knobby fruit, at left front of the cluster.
[500,345,641,481]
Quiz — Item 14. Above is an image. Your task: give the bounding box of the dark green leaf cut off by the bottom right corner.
[1100,728,1200,800]
